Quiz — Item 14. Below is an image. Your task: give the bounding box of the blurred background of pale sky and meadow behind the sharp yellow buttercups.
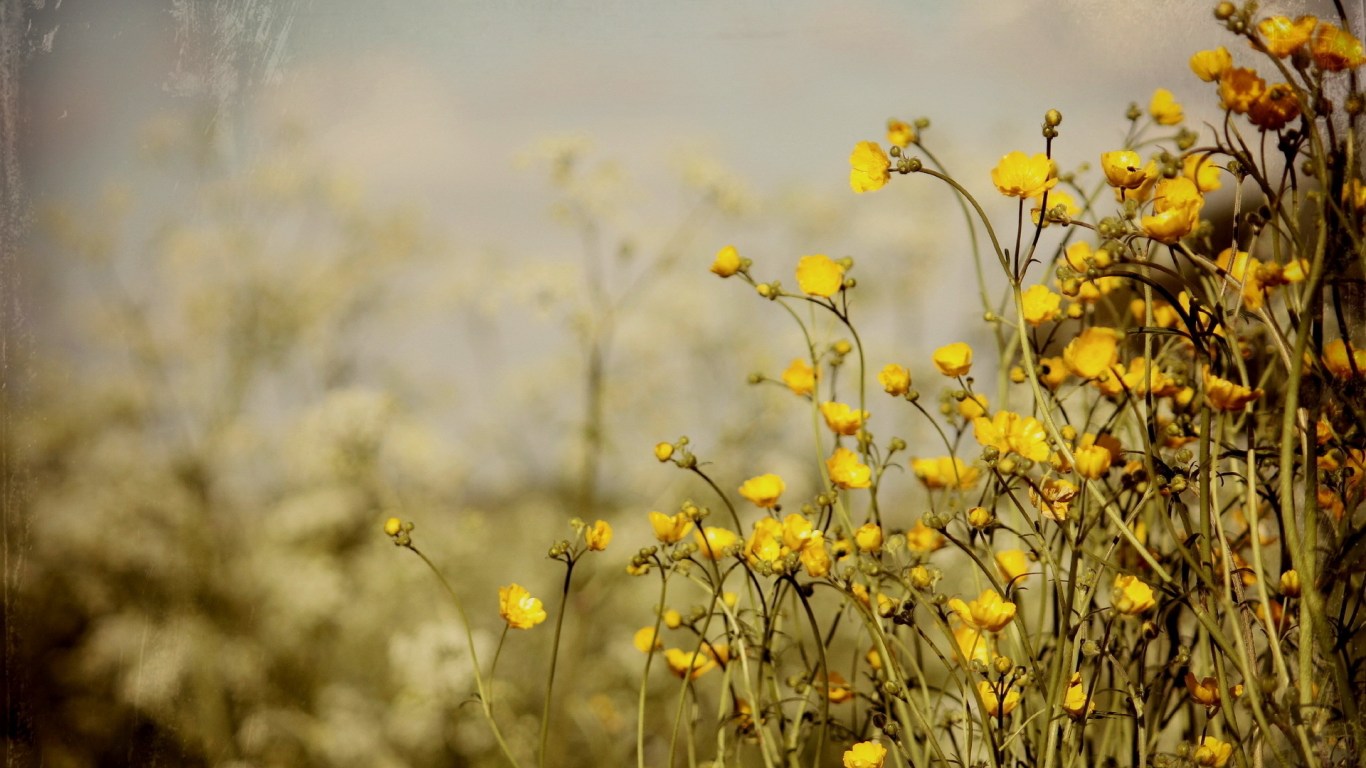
[0,0,1322,767]
